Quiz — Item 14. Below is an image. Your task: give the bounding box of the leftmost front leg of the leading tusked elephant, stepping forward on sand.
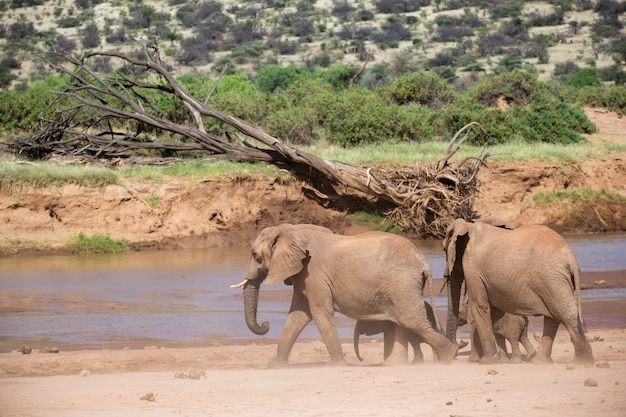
[270,292,312,368]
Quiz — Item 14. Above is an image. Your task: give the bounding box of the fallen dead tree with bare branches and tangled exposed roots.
[6,46,487,237]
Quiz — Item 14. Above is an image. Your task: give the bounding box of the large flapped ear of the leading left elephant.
[265,224,309,284]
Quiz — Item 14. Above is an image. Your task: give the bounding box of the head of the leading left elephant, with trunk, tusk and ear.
[233,224,322,335]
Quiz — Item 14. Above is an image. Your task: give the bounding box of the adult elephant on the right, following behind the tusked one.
[443,219,594,365]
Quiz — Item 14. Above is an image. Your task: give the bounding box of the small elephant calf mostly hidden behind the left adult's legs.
[353,301,439,363]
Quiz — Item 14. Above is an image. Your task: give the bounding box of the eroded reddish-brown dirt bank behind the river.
[0,109,626,256]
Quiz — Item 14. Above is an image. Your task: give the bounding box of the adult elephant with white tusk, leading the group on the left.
[235,224,458,367]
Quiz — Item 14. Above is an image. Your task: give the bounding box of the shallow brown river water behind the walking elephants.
[0,234,626,351]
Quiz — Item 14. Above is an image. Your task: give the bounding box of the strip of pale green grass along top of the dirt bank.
[0,141,626,188]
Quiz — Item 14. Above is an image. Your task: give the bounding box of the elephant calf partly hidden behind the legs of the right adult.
[459,297,537,363]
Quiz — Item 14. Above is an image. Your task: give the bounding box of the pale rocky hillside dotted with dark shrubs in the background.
[0,0,626,87]
